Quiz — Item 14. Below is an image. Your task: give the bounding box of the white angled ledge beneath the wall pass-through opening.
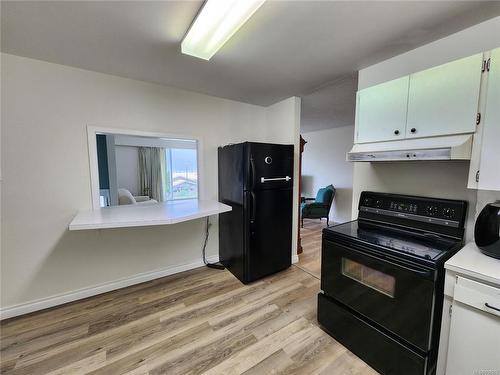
[69,199,231,230]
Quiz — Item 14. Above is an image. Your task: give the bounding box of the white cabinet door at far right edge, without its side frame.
[477,48,500,190]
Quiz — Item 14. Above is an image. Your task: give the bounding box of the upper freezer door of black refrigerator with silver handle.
[246,143,293,191]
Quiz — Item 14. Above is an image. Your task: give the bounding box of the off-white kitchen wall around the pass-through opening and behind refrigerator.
[1,54,300,317]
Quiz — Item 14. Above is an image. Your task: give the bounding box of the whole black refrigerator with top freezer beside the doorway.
[218,142,293,284]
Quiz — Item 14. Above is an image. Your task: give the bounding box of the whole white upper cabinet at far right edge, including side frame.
[468,48,500,190]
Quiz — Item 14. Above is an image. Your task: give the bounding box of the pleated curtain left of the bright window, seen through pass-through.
[139,147,165,202]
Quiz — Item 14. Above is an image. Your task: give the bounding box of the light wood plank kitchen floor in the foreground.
[0,266,376,375]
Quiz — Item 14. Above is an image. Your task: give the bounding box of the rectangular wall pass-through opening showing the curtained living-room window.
[96,133,198,207]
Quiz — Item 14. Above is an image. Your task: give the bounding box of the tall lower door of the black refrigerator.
[246,189,293,282]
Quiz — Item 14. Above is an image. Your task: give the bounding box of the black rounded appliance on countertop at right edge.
[474,201,500,259]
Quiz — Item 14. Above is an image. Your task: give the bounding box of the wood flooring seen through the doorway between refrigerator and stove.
[297,219,332,279]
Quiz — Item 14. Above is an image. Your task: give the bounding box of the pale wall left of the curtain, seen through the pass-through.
[115,146,142,195]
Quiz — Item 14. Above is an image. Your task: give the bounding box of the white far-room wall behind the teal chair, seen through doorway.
[302,126,354,223]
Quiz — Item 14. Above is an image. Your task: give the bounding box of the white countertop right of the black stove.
[444,242,500,285]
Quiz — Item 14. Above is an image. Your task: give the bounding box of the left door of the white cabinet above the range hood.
[356,76,409,143]
